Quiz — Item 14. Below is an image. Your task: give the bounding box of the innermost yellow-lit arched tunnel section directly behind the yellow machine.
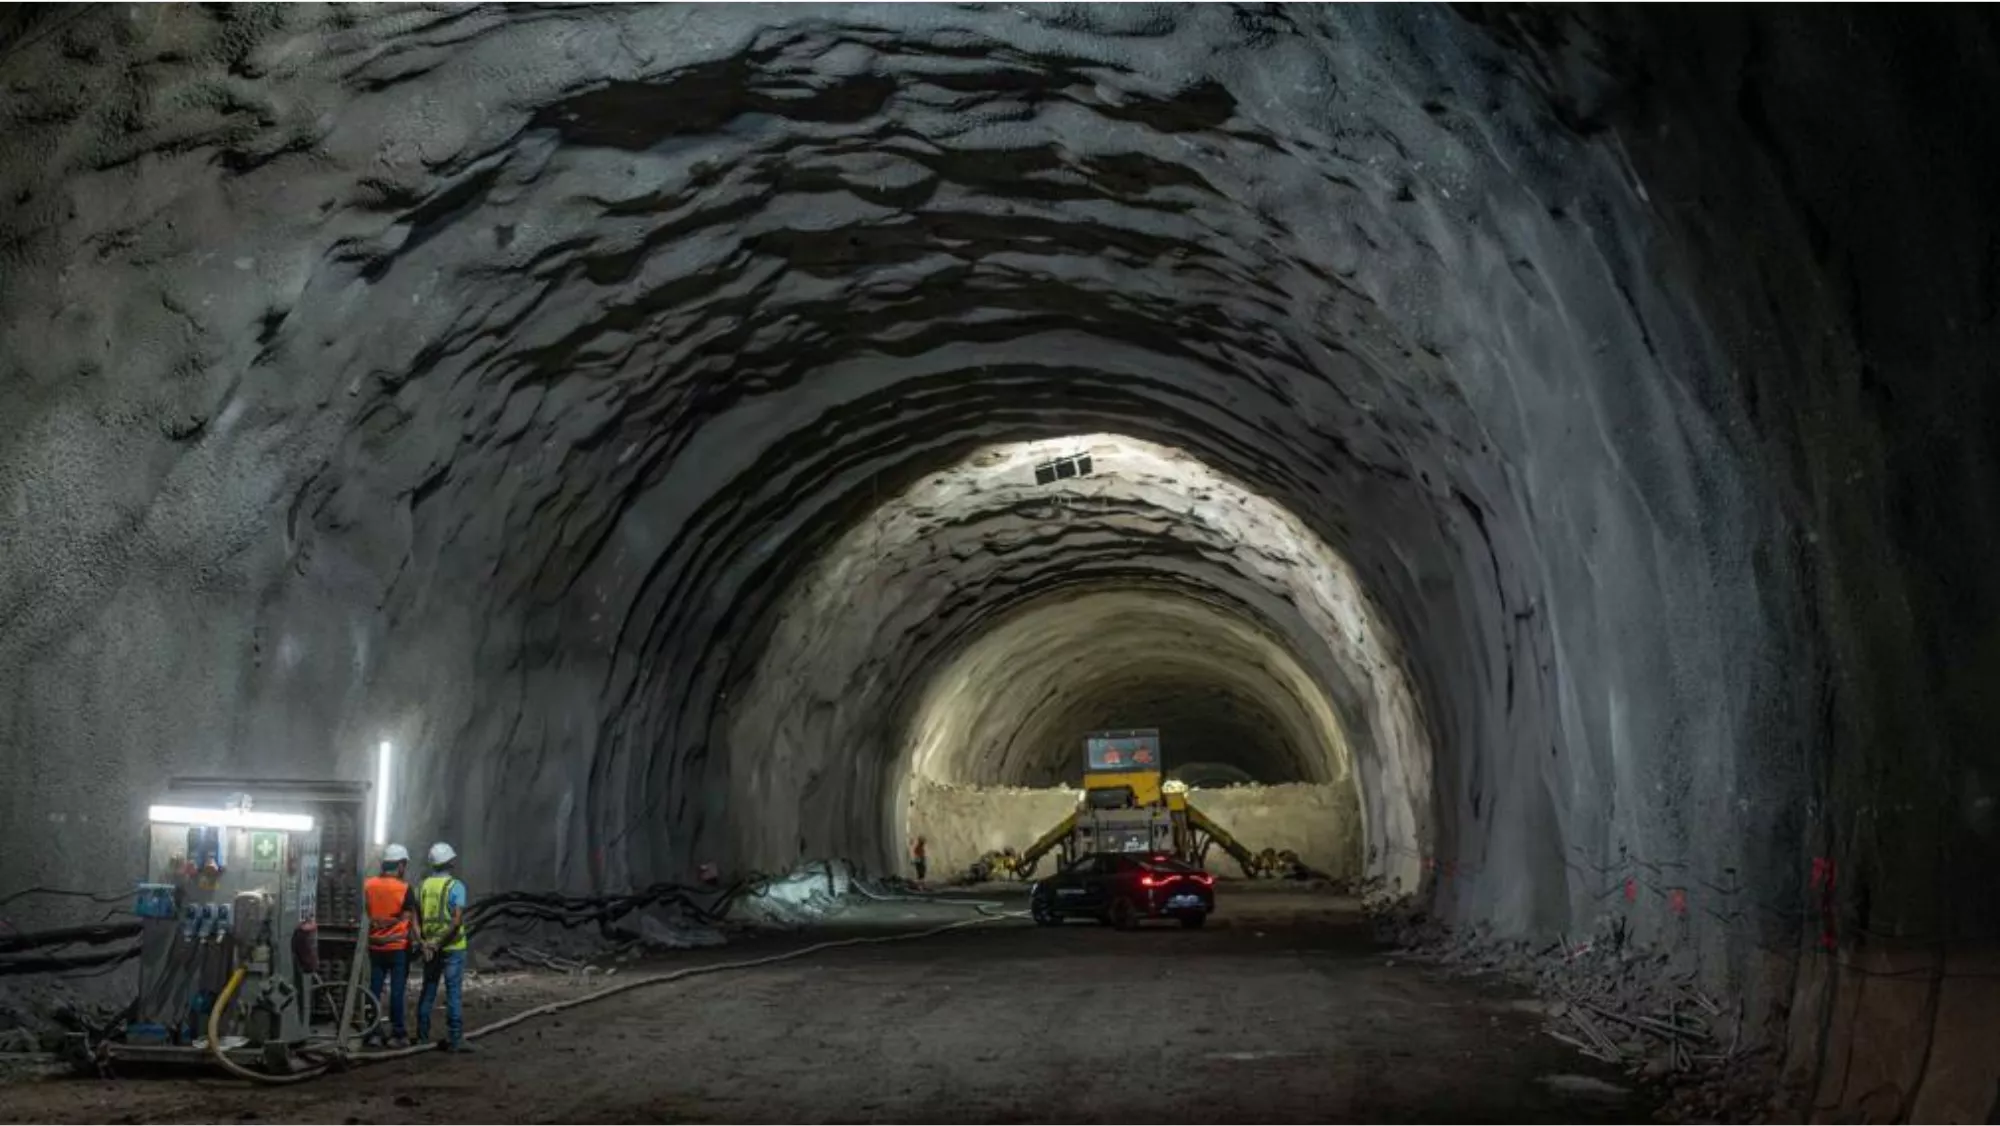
[898,588,1364,880]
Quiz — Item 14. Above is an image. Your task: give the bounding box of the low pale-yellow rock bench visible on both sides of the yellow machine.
[910,778,1362,880]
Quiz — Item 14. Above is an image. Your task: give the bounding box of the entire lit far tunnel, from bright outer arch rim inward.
[728,432,1430,878]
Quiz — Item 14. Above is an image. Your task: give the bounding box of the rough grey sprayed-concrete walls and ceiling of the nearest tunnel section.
[0,6,2000,1112]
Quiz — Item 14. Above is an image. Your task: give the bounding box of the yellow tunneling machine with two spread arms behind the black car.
[974,728,1296,878]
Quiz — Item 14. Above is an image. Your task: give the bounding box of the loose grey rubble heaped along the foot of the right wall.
[1376,902,1776,1122]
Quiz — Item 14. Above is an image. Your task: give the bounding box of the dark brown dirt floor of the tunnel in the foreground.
[0,888,1650,1122]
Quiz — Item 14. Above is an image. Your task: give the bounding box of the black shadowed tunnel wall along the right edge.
[1572,8,2000,1122]
